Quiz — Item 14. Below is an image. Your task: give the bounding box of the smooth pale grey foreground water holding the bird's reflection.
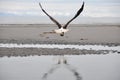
[0,53,120,80]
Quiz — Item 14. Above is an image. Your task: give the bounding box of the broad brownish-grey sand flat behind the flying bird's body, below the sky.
[0,24,120,43]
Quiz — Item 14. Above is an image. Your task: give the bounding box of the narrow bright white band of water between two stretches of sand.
[0,43,120,51]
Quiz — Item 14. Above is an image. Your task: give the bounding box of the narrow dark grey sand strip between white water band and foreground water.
[0,48,120,57]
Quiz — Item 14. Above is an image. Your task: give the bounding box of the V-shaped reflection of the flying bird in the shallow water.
[42,56,82,80]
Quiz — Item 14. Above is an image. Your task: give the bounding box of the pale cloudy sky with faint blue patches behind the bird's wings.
[0,0,120,24]
